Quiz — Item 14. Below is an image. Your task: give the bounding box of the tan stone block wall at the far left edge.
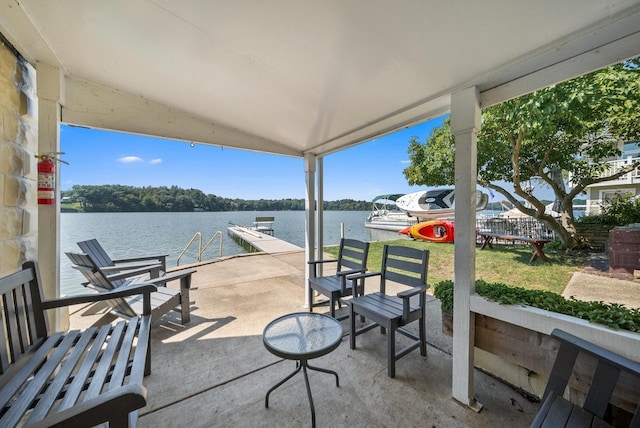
[0,40,38,276]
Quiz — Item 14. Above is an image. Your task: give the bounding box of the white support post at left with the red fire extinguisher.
[36,63,69,330]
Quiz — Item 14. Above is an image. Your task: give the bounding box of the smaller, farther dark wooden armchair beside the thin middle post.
[308,238,369,320]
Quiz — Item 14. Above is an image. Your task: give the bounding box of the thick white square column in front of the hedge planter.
[451,87,482,411]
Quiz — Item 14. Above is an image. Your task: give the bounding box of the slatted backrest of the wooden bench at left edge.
[0,264,47,378]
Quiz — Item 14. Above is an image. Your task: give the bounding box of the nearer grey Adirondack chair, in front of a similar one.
[65,252,196,324]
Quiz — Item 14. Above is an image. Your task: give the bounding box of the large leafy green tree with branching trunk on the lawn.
[404,58,640,248]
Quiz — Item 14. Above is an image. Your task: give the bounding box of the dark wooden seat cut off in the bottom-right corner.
[531,329,640,428]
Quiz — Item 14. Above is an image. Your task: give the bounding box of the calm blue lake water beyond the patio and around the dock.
[60,211,398,295]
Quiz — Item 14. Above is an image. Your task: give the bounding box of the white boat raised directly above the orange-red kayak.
[396,187,489,219]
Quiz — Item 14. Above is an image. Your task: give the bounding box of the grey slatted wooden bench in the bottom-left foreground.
[0,262,156,427]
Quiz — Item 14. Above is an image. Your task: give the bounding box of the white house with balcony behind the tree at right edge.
[585,142,640,214]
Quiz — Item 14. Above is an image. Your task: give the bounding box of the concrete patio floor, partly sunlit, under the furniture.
[71,252,538,427]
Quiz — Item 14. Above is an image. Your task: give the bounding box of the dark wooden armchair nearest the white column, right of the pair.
[347,245,429,377]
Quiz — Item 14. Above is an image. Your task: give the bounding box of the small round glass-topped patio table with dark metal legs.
[262,312,342,427]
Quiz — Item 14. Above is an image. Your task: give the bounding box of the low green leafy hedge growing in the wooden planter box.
[433,279,640,332]
